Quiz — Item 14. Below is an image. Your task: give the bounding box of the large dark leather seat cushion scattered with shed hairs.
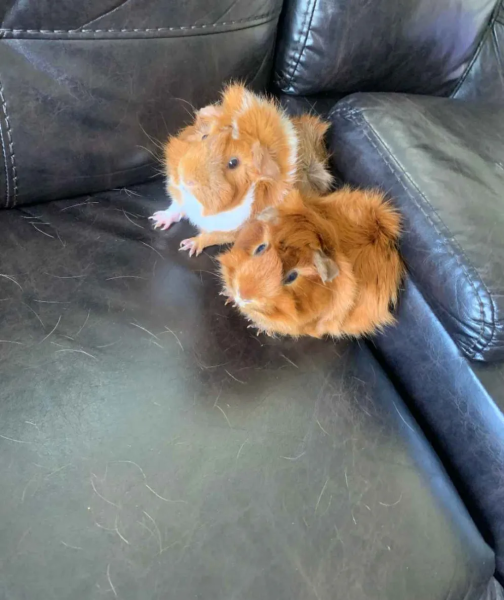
[0,183,494,600]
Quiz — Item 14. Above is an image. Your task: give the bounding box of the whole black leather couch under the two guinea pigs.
[0,0,504,600]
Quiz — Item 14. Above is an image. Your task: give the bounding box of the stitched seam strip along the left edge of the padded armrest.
[332,107,495,358]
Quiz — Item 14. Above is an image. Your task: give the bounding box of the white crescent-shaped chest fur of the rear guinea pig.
[178,181,255,232]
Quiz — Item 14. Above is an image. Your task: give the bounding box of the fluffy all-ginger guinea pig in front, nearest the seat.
[219,188,403,338]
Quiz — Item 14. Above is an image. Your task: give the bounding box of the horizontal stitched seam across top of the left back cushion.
[0,10,280,39]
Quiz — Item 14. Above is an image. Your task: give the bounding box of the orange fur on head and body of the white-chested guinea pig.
[165,85,296,215]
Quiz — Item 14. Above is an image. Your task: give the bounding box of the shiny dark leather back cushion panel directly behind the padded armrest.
[276,0,494,95]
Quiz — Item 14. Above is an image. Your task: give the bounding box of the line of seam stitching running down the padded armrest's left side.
[340,111,495,358]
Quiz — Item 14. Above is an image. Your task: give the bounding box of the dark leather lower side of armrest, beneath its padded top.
[374,279,504,581]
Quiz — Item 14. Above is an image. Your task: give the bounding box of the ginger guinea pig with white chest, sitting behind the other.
[151,84,332,255]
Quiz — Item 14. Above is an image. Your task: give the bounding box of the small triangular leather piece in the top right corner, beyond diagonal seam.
[453,2,504,104]
